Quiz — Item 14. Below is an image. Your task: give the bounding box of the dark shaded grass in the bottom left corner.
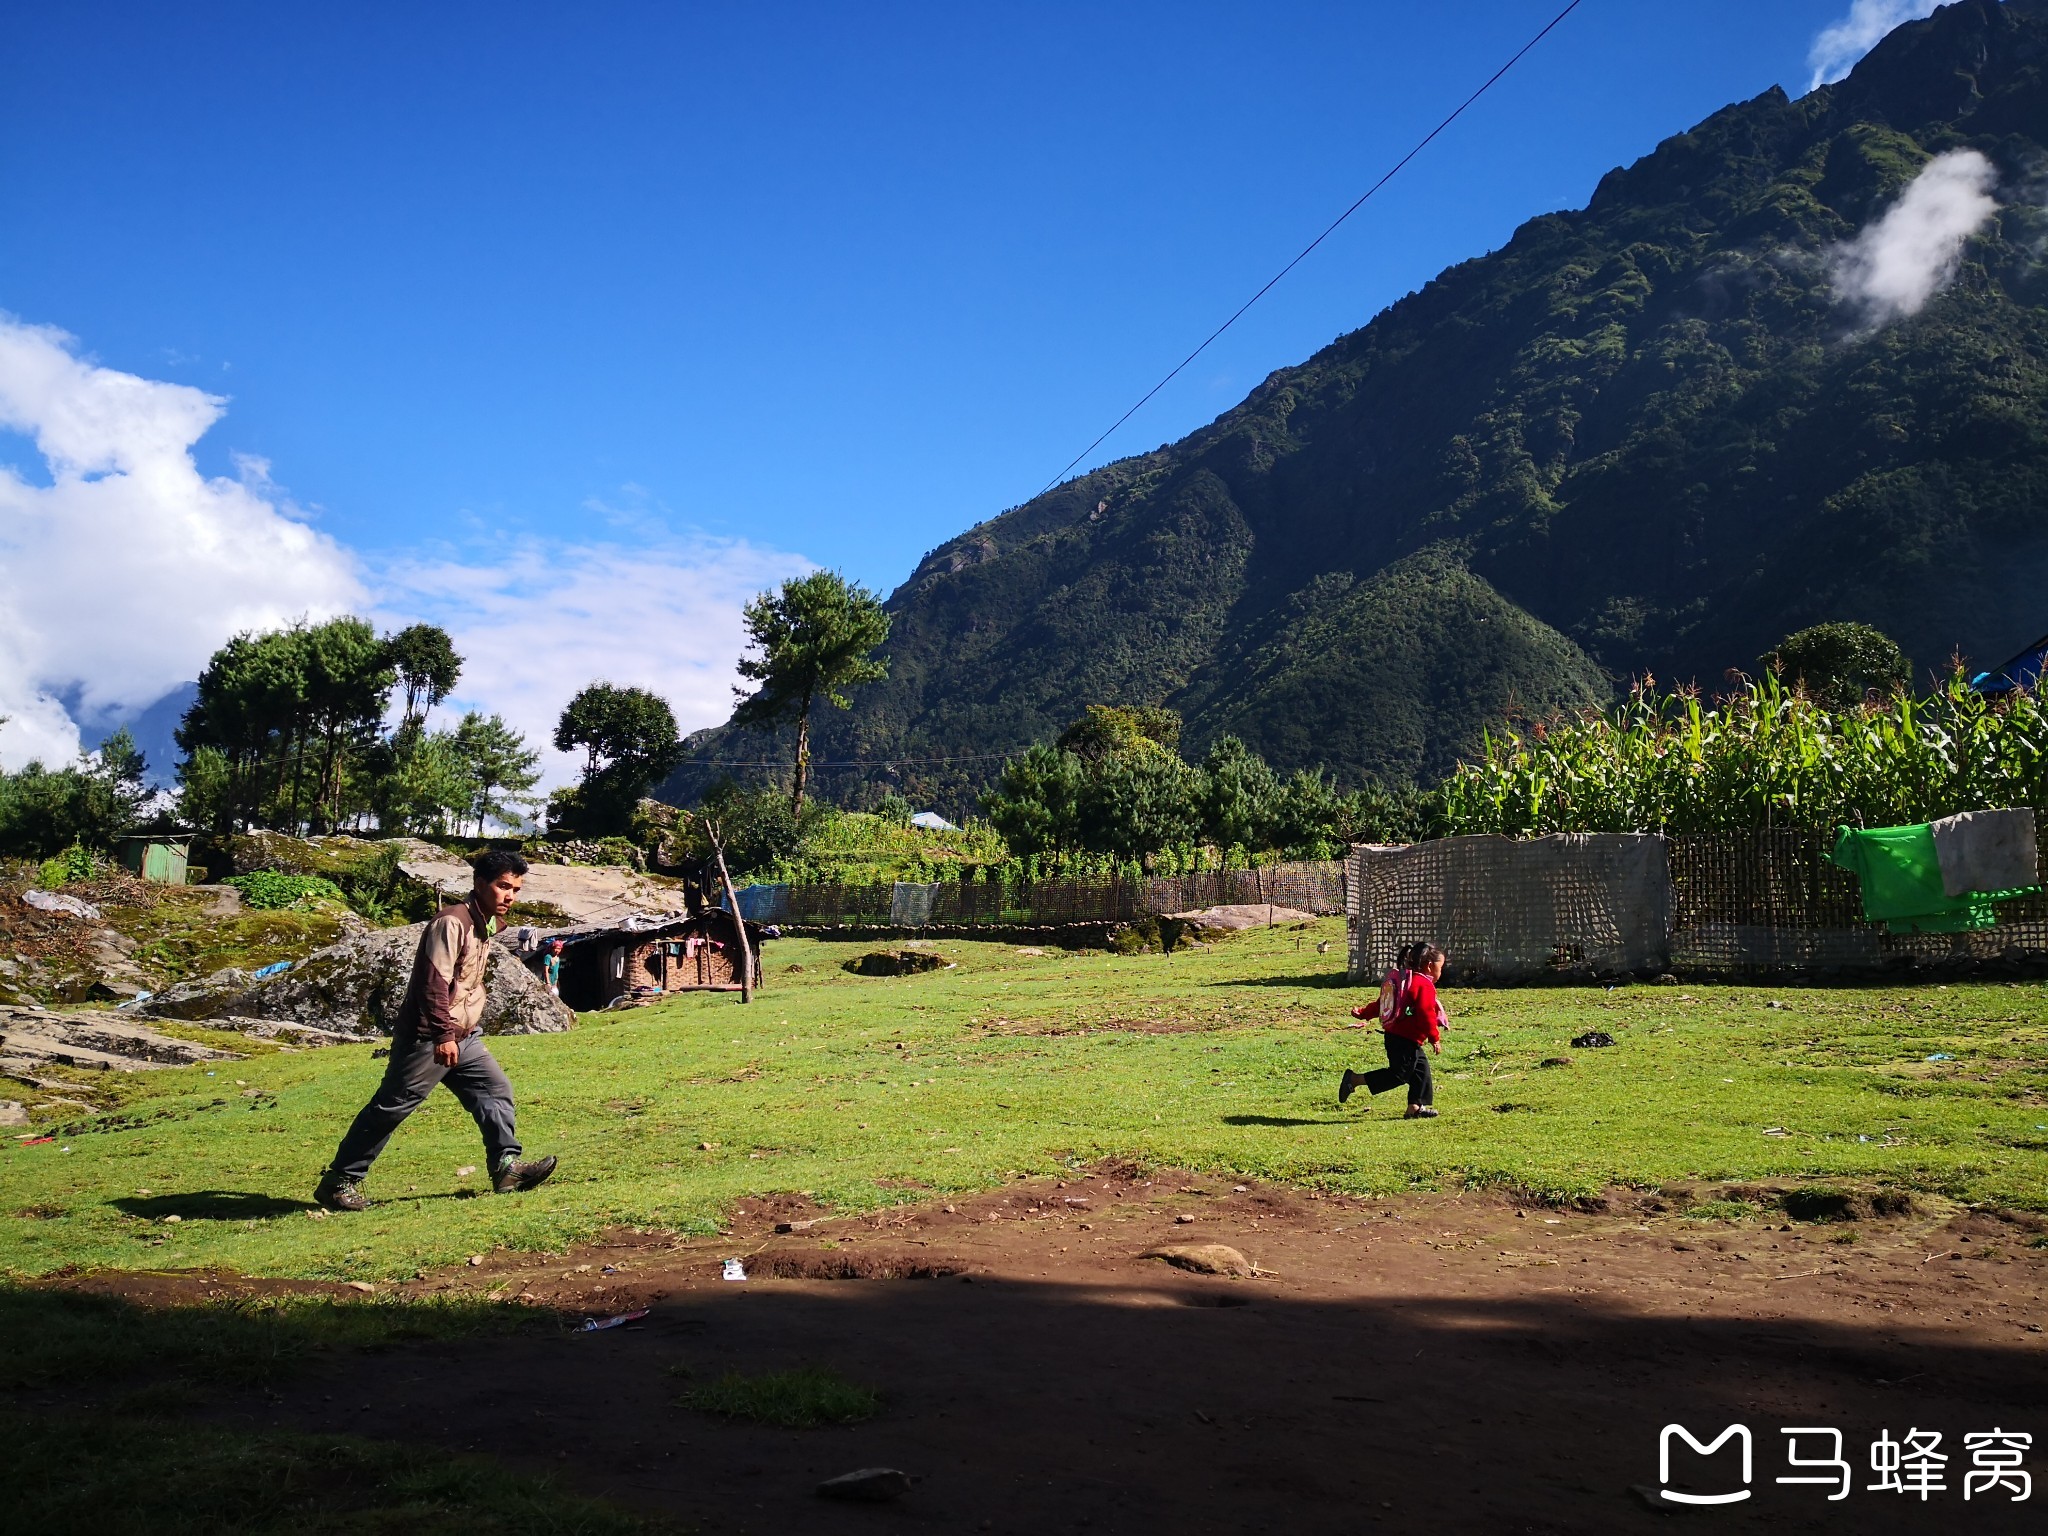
[0,1284,676,1536]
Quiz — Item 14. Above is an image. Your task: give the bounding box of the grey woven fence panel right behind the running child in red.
[1350,834,1671,983]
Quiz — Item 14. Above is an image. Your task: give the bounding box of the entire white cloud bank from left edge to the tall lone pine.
[0,313,811,784]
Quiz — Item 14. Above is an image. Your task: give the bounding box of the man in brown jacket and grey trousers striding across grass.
[313,850,555,1210]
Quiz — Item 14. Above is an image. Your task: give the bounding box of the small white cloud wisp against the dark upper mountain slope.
[1827,150,1999,326]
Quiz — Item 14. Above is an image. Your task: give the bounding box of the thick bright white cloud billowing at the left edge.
[0,313,362,768]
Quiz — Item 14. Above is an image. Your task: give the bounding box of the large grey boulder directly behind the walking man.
[135,924,575,1038]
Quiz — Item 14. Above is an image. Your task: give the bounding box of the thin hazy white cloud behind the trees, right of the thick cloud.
[379,526,813,786]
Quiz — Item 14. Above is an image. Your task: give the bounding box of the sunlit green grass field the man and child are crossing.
[12,920,2048,1280]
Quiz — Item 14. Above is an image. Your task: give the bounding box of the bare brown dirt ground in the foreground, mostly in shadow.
[32,1167,2048,1534]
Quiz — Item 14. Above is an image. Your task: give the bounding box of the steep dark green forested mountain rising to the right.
[672,0,2048,809]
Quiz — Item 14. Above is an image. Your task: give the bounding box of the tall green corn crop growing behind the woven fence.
[1440,674,2048,838]
